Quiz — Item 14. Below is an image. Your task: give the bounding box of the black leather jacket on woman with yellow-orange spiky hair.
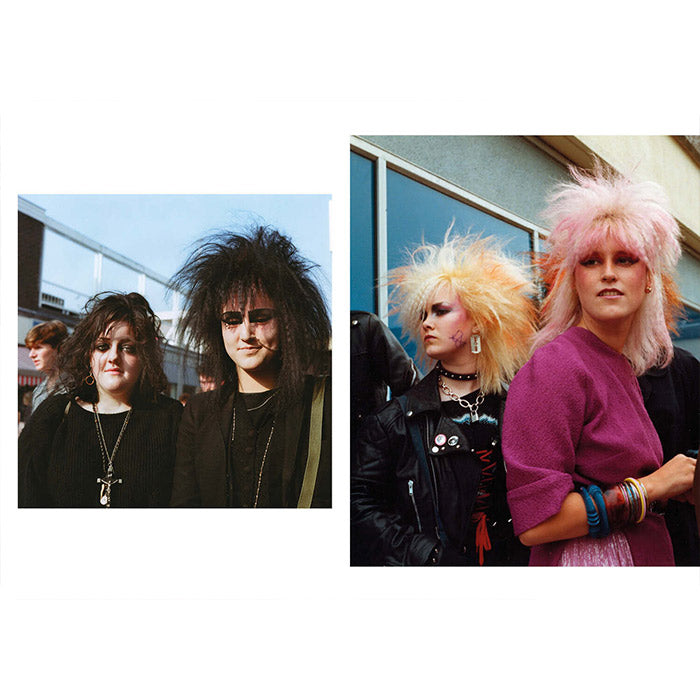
[351,370,528,566]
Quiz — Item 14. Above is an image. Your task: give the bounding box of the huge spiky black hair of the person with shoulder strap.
[171,226,331,410]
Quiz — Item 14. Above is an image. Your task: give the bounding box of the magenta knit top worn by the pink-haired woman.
[502,327,673,566]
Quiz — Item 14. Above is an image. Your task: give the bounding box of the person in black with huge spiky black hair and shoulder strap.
[171,227,331,508]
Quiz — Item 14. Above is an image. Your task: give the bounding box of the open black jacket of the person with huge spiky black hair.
[170,377,331,508]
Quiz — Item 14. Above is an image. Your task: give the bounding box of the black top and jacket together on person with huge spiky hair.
[170,376,332,508]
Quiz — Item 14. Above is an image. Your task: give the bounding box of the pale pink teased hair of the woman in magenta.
[533,164,681,375]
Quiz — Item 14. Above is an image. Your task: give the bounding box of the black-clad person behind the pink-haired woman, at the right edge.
[639,345,700,566]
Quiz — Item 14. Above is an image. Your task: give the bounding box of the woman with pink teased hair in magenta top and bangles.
[503,164,695,566]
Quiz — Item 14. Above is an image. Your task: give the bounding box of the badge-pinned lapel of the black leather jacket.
[406,369,471,457]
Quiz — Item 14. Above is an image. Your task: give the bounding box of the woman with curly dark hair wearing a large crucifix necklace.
[19,292,182,508]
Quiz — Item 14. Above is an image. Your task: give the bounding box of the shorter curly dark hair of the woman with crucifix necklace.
[58,292,168,405]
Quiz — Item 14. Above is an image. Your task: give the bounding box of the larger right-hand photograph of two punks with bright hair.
[350,135,700,566]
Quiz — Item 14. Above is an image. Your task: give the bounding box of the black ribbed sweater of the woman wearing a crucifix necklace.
[18,394,182,508]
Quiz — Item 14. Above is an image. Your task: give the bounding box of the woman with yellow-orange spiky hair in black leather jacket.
[351,231,535,566]
